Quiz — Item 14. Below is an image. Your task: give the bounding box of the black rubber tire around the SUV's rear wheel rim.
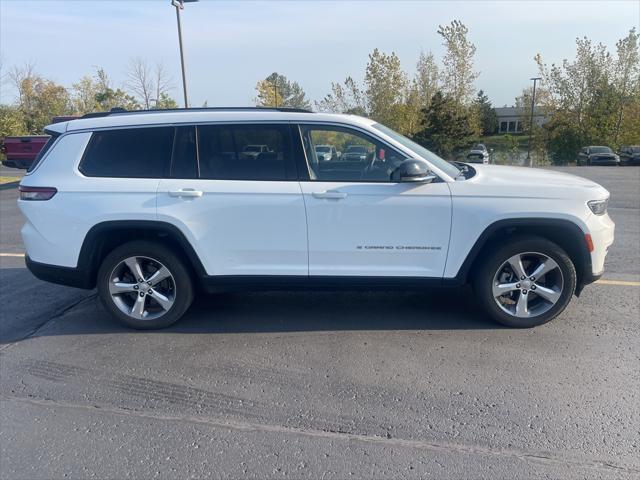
[97,240,193,330]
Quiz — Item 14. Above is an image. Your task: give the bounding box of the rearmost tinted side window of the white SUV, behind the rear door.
[80,127,174,178]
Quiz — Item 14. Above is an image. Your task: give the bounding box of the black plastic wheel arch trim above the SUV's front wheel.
[455,218,591,295]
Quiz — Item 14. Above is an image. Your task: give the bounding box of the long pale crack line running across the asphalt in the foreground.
[0,394,640,475]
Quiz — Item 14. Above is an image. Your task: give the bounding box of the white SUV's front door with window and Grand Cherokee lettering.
[299,124,451,278]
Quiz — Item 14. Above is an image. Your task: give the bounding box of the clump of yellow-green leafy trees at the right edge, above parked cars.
[535,29,640,163]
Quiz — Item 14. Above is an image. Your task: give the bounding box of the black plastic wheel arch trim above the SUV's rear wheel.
[78,220,206,288]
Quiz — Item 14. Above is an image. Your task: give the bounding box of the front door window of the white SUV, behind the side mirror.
[300,125,406,182]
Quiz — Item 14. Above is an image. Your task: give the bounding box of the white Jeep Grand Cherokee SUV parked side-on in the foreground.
[18,109,614,328]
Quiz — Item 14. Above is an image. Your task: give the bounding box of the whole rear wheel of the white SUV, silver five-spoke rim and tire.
[97,241,193,329]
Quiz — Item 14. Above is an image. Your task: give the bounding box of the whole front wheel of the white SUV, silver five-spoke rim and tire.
[474,237,576,328]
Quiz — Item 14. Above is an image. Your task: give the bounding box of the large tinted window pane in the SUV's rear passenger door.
[198,124,296,181]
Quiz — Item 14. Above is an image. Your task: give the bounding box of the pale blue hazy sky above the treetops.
[0,0,640,106]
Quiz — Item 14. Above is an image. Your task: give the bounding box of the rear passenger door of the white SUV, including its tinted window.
[157,123,308,276]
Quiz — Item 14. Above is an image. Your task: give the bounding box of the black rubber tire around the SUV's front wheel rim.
[473,236,577,328]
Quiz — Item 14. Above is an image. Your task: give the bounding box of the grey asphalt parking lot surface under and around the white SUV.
[0,167,640,479]
